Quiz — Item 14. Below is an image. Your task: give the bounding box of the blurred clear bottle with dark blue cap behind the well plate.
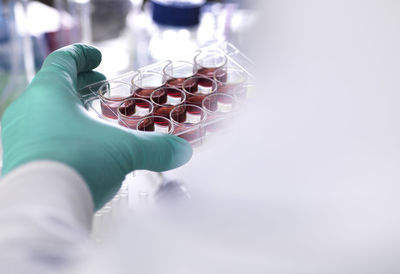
[134,0,205,67]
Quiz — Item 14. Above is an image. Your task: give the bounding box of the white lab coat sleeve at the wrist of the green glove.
[0,161,94,274]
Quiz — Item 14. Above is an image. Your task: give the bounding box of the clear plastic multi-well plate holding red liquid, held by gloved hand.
[78,43,254,144]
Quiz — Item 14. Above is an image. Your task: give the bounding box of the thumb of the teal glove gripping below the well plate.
[118,131,193,172]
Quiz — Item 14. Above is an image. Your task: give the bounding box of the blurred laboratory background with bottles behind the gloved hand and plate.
[0,0,257,113]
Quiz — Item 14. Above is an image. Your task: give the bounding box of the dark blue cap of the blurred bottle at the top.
[152,0,205,27]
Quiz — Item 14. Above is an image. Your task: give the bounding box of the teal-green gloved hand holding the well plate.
[2,44,192,209]
